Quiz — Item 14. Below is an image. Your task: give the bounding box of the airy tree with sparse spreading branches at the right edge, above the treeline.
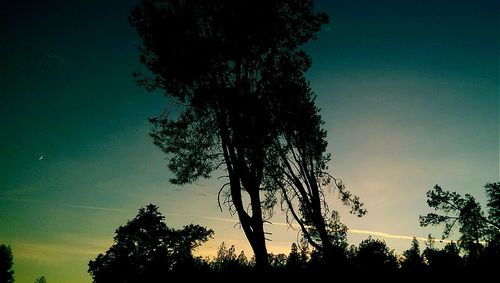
[420,182,500,259]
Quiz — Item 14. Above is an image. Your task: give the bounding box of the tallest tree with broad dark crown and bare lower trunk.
[130,0,327,268]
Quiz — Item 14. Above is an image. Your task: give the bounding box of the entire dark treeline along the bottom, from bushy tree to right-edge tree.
[89,182,500,283]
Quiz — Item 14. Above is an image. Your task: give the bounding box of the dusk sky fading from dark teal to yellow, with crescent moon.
[0,0,500,283]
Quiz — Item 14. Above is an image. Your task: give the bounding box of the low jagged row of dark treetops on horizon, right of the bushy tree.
[206,233,500,274]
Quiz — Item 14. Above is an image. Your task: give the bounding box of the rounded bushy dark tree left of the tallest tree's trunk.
[88,204,213,282]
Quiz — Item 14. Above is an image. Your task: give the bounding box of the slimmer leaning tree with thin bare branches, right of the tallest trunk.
[264,82,366,260]
